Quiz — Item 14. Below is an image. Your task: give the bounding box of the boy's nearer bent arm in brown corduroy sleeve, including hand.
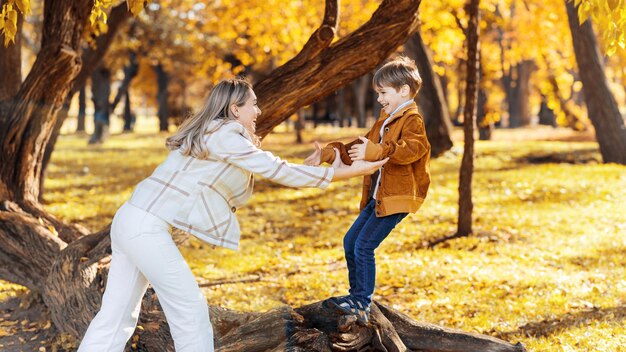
[365,115,430,165]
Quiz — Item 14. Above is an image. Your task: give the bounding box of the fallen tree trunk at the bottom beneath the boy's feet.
[136,292,525,352]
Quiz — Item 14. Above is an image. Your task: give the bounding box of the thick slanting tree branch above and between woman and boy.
[255,0,421,137]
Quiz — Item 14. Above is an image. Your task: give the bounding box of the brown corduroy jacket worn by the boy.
[320,103,430,217]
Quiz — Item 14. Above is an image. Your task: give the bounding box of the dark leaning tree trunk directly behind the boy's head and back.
[404,31,452,156]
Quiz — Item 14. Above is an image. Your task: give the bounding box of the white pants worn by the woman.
[78,203,213,352]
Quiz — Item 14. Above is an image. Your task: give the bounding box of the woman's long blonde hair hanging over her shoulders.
[165,78,258,159]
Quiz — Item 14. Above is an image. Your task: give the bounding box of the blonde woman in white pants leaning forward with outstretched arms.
[78,79,386,352]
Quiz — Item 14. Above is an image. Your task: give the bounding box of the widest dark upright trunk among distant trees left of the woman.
[89,66,111,144]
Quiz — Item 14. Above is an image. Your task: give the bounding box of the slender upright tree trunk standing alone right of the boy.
[457,0,480,236]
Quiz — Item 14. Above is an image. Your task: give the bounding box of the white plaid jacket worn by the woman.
[129,122,334,249]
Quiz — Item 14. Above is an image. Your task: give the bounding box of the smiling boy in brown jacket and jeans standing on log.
[305,57,430,324]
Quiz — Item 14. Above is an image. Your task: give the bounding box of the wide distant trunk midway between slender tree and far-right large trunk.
[506,60,534,128]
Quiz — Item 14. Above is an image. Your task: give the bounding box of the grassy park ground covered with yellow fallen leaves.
[0,122,626,351]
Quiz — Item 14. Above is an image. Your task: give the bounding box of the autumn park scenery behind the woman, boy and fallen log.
[0,0,626,351]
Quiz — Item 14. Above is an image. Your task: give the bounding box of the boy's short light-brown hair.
[372,56,422,98]
